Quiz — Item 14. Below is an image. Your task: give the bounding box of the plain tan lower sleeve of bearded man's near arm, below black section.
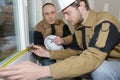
[50,48,106,79]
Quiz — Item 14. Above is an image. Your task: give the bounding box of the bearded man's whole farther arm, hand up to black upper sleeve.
[32,34,82,60]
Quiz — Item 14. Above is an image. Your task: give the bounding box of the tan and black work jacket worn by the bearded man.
[50,10,120,79]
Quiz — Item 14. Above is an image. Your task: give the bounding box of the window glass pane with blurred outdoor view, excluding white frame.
[0,0,17,62]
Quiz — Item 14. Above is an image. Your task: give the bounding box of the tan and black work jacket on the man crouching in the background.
[34,19,72,48]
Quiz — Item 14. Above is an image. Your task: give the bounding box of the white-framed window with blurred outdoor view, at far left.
[0,0,29,65]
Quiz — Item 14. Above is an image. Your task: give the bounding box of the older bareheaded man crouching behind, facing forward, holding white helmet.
[33,3,72,66]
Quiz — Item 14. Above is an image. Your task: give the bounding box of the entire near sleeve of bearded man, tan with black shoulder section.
[50,22,120,79]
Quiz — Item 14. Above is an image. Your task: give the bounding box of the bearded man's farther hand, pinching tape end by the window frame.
[30,45,50,57]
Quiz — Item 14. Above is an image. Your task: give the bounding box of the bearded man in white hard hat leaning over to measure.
[0,0,120,80]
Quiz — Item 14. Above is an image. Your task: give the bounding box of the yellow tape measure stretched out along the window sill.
[1,44,33,68]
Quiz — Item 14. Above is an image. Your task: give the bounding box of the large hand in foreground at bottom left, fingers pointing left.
[0,62,51,80]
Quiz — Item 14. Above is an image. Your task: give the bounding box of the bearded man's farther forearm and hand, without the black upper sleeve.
[31,45,81,60]
